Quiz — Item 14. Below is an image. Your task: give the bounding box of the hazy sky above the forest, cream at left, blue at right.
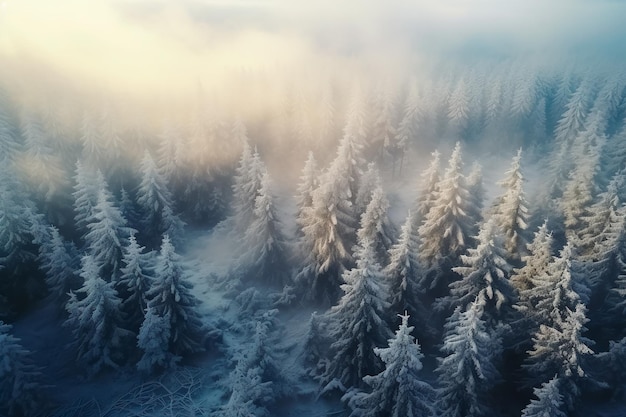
[0,0,626,122]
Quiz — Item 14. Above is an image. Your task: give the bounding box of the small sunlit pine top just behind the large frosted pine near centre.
[357,187,395,266]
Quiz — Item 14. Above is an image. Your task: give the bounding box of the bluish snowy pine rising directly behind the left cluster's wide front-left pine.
[84,187,135,282]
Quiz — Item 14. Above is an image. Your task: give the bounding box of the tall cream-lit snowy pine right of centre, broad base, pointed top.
[418,142,474,267]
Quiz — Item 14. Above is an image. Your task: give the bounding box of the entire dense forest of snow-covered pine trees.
[0,60,626,417]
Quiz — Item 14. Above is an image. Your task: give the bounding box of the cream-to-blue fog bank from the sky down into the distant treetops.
[0,0,626,184]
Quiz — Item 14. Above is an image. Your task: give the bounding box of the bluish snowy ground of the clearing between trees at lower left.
[8,224,336,417]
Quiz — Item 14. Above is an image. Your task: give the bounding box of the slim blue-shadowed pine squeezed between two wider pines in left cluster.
[116,233,153,333]
